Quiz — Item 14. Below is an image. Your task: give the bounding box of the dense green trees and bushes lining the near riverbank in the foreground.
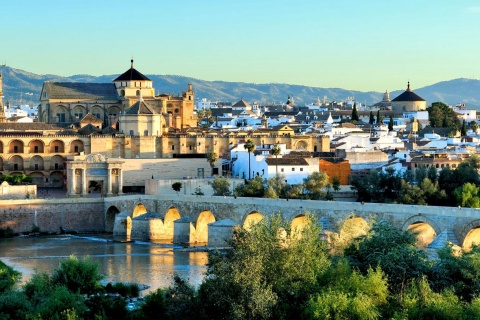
[4,215,480,320]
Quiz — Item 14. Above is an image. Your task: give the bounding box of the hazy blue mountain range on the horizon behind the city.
[0,66,480,109]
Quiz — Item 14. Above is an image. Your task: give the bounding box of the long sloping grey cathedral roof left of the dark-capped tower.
[43,81,118,100]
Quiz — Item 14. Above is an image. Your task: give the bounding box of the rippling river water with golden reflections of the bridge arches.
[0,236,207,292]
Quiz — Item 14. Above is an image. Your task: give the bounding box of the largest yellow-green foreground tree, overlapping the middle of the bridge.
[199,215,330,319]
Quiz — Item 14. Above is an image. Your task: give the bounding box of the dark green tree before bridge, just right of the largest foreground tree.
[344,222,428,293]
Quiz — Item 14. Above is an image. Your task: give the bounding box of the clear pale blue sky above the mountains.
[0,0,480,92]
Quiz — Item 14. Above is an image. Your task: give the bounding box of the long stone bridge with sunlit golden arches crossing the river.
[104,195,480,249]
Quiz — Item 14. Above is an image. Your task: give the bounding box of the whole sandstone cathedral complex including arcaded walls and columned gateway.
[0,60,330,191]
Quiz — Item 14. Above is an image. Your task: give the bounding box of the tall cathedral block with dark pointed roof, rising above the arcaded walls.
[38,60,197,132]
